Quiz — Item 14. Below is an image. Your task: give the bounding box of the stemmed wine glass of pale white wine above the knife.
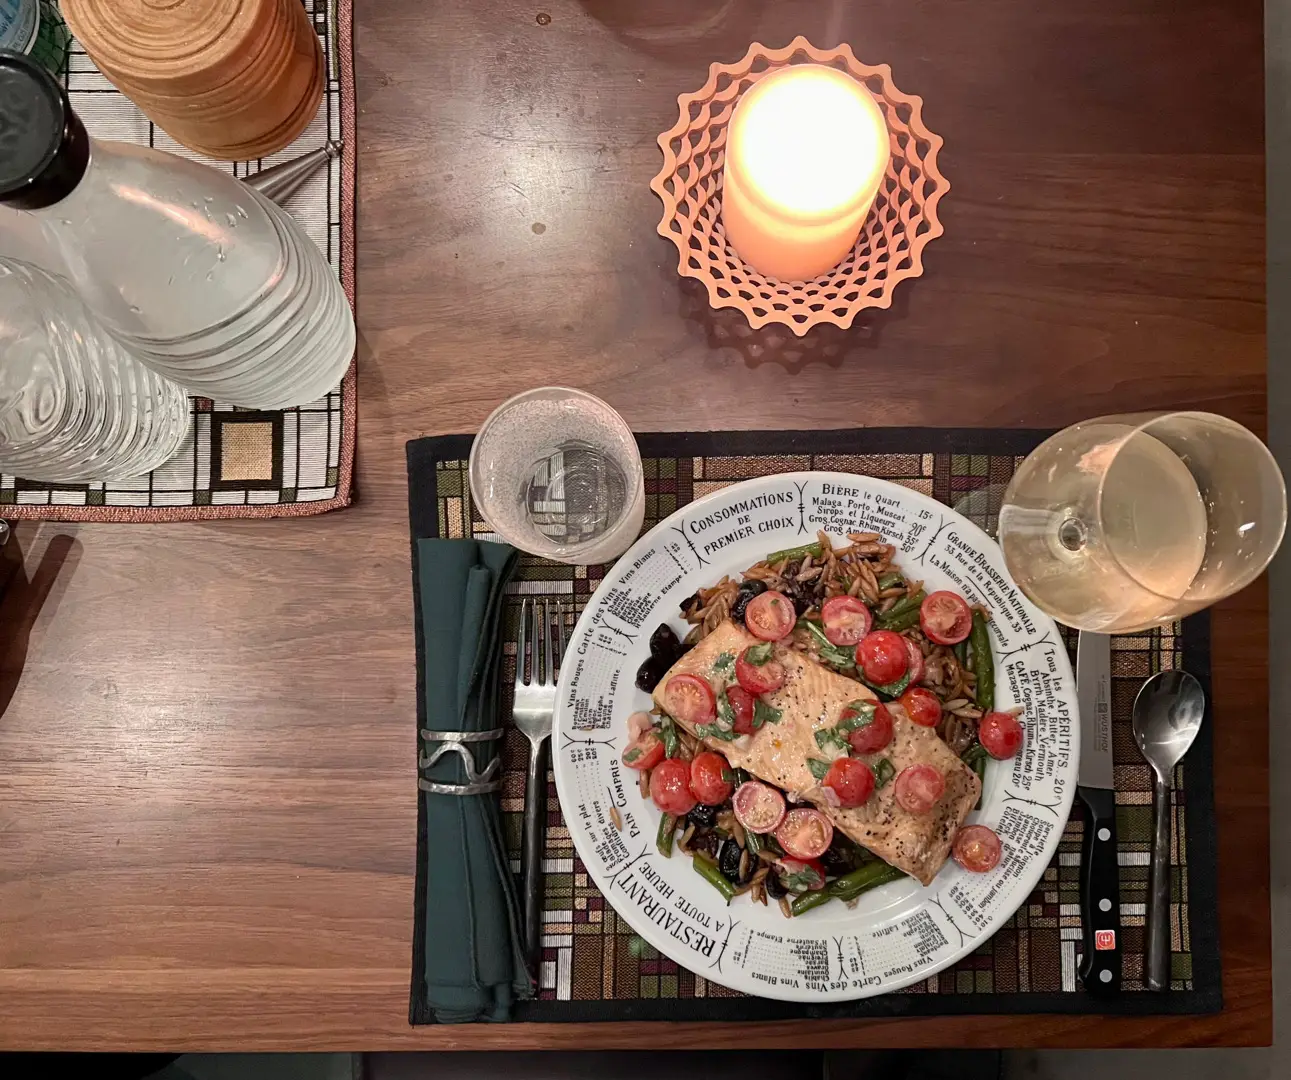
[999,413,1287,634]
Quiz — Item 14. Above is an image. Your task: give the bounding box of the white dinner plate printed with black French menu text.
[553,472,1079,1001]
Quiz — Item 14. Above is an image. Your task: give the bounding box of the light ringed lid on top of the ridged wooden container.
[62,0,284,94]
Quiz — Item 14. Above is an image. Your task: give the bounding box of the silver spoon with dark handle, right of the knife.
[1133,671,1206,990]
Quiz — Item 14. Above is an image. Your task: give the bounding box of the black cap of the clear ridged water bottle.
[0,49,89,210]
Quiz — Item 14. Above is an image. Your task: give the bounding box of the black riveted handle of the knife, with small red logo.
[1081,787,1121,994]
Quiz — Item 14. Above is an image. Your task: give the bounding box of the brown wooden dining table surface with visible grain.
[0,0,1272,1050]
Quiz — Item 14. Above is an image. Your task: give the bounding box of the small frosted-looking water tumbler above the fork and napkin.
[470,386,646,564]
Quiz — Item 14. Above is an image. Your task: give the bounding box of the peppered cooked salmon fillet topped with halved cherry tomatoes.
[655,619,981,885]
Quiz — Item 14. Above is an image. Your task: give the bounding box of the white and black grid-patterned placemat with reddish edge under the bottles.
[0,0,356,521]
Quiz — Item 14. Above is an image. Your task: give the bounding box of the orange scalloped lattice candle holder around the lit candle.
[649,36,950,337]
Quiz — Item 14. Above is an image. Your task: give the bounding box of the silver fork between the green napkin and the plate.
[511,599,565,978]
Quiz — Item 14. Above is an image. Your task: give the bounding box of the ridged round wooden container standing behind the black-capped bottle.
[62,0,325,161]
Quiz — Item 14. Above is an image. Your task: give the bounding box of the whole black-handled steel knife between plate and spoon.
[1075,632,1121,994]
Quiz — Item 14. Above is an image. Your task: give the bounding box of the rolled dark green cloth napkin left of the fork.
[417,539,532,1023]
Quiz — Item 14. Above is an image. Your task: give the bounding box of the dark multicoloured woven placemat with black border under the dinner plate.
[408,428,1223,1023]
